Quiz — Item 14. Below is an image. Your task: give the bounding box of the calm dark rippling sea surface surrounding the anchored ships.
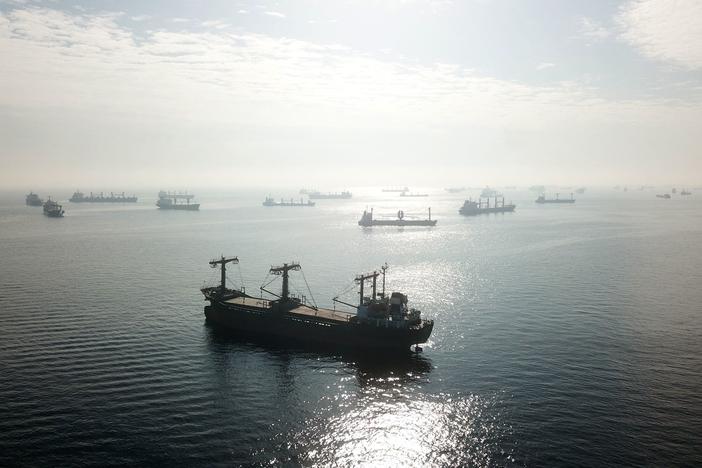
[0,189,702,467]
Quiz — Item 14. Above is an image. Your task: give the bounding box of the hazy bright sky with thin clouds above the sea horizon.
[0,0,702,191]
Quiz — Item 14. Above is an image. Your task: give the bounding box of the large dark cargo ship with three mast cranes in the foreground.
[201,256,434,352]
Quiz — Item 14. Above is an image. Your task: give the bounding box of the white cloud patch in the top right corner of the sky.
[616,0,702,70]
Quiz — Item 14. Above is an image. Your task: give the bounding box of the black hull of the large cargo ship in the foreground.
[205,302,434,352]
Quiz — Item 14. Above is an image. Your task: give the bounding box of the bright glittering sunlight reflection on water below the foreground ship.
[288,390,509,466]
